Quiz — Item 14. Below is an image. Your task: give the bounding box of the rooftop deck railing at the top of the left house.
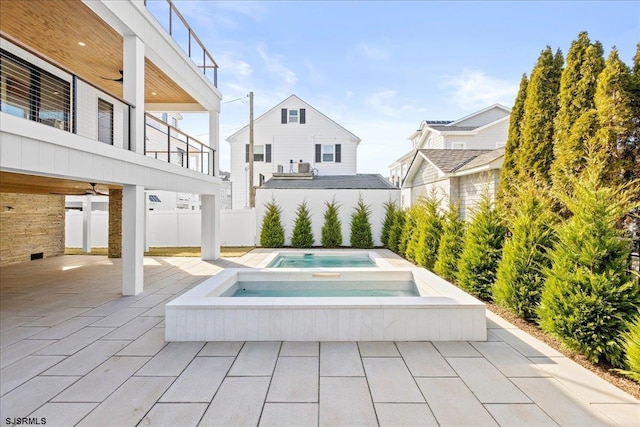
[144,0,218,87]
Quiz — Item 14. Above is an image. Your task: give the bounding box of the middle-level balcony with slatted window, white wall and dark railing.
[0,37,215,176]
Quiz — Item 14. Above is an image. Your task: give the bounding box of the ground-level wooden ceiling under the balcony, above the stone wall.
[0,172,122,196]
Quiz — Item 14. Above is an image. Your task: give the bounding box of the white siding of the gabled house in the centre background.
[227,96,358,209]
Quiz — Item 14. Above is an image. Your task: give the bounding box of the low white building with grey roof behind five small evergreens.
[256,174,399,246]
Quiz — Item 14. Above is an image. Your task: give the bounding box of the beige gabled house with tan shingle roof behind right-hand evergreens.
[402,147,504,219]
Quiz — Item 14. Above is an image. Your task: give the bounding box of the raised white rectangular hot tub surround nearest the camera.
[165,268,487,341]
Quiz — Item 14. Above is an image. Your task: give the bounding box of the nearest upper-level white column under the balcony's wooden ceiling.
[122,36,144,153]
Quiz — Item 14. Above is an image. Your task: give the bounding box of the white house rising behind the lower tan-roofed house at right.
[389,104,511,207]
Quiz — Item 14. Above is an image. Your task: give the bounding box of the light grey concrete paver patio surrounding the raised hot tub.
[0,250,640,426]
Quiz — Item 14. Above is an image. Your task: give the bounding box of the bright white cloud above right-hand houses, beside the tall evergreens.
[441,70,518,109]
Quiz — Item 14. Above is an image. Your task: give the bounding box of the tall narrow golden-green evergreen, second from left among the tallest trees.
[518,46,563,186]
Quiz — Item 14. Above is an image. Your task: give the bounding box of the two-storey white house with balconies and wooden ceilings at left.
[0,0,222,295]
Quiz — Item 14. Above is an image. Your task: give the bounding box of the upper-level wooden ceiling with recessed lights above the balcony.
[0,0,196,104]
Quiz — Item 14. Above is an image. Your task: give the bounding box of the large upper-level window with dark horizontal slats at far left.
[0,49,71,131]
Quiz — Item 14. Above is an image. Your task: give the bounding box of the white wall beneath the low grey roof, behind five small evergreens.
[256,188,400,246]
